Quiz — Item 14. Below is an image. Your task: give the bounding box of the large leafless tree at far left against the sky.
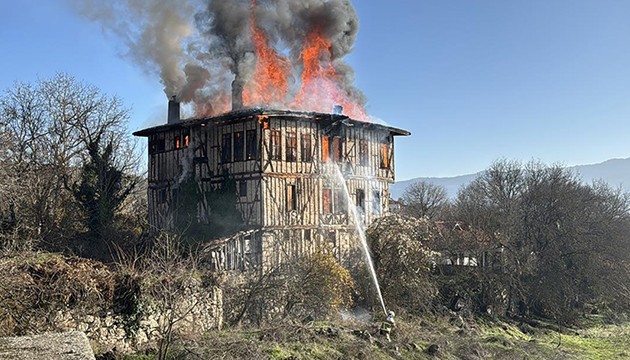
[0,74,139,253]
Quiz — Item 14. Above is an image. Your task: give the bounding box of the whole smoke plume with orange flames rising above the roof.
[75,0,367,119]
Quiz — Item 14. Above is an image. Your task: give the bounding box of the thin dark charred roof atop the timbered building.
[133,108,411,137]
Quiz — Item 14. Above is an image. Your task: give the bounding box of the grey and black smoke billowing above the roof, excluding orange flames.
[75,0,364,112]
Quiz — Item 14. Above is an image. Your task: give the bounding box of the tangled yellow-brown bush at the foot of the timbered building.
[223,249,355,325]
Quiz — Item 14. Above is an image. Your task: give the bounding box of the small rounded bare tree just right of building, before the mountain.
[402,181,449,219]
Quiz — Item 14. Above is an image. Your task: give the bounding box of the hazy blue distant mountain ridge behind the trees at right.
[390,158,630,199]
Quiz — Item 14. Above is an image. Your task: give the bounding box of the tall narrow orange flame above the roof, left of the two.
[243,0,290,106]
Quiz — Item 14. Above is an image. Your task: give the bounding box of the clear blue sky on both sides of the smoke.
[0,0,630,180]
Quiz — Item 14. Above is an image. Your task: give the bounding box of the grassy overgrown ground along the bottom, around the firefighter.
[136,315,630,360]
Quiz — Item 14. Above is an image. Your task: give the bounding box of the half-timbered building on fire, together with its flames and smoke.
[101,0,409,269]
